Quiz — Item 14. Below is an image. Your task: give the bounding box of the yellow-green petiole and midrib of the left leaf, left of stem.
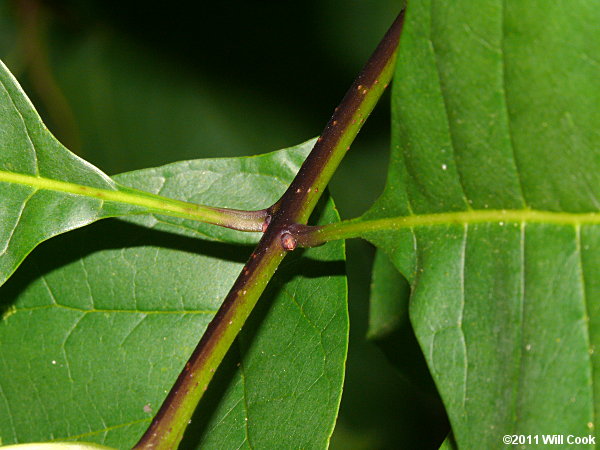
[0,170,267,231]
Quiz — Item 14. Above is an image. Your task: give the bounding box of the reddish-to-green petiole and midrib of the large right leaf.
[292,209,600,247]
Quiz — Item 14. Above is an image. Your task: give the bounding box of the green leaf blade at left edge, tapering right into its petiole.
[0,62,135,285]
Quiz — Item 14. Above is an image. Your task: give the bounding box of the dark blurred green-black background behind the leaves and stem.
[0,0,445,449]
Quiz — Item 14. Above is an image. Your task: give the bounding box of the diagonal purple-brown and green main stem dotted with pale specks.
[135,12,404,449]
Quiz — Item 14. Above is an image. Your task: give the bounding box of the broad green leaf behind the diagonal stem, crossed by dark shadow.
[0,144,348,448]
